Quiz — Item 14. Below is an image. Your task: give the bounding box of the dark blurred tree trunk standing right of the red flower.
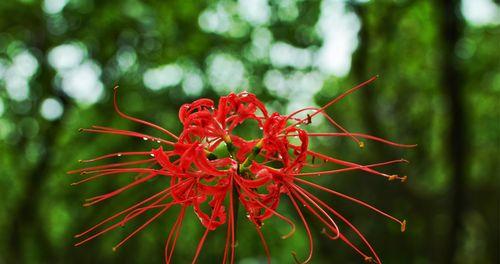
[436,0,467,263]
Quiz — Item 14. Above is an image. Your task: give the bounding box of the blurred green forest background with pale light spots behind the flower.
[0,0,500,264]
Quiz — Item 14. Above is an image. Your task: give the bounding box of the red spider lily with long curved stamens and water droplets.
[69,77,414,263]
